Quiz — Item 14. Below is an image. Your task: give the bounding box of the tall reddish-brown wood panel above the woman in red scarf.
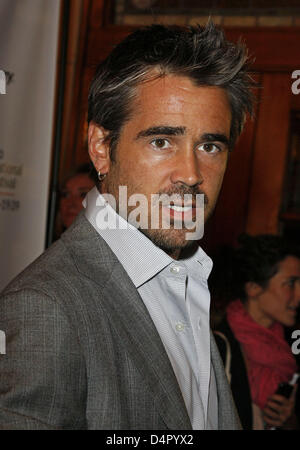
[246,73,291,234]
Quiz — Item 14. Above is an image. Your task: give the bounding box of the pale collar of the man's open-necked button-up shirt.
[83,187,212,288]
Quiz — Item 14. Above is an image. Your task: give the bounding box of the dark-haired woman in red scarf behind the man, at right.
[210,235,300,429]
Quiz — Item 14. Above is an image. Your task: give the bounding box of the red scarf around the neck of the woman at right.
[226,300,297,409]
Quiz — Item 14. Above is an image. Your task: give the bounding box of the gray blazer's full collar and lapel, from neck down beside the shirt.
[63,214,192,429]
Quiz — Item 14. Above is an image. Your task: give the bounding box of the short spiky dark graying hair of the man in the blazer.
[88,21,255,158]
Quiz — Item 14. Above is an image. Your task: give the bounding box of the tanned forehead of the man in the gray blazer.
[131,75,231,133]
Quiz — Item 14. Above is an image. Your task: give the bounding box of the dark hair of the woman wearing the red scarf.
[209,234,300,303]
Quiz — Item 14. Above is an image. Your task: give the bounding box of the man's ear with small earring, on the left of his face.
[88,122,110,175]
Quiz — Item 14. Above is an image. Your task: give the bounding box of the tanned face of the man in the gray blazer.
[92,75,231,253]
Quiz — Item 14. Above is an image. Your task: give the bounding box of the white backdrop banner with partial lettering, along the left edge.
[0,0,60,291]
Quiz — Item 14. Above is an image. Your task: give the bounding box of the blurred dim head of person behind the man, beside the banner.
[55,163,96,239]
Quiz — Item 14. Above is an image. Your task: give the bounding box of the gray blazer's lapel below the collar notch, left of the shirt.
[104,264,191,429]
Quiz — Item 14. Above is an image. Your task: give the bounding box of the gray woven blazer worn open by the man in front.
[0,213,240,430]
